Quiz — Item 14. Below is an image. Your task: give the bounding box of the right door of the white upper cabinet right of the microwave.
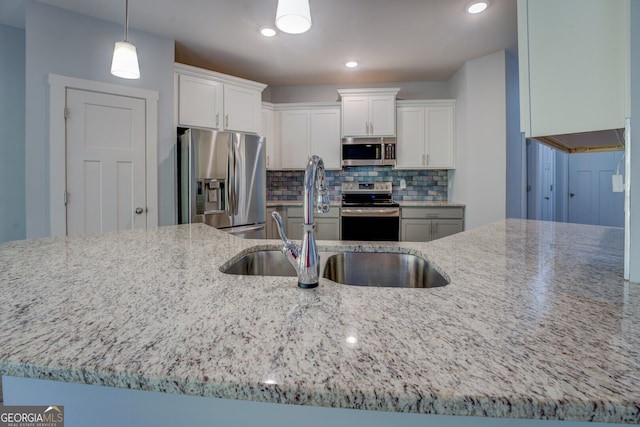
[425,106,455,169]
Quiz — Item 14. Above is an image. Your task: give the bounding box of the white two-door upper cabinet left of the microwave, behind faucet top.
[276,103,341,169]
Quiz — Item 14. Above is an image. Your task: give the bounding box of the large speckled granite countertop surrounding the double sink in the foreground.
[0,220,640,423]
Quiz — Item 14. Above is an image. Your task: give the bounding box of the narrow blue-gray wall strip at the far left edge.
[0,25,26,243]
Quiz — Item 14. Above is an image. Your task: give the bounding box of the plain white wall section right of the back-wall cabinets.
[449,51,507,229]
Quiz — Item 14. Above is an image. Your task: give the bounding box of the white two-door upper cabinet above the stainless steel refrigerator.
[175,64,266,133]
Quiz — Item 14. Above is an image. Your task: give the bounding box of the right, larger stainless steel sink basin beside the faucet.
[322,252,449,288]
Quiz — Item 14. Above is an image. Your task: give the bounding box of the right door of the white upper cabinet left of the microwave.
[309,108,342,169]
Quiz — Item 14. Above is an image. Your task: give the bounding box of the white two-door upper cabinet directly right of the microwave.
[396,99,455,169]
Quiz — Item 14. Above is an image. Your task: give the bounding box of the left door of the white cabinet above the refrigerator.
[178,74,223,129]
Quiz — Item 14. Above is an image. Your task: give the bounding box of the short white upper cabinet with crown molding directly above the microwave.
[338,88,400,137]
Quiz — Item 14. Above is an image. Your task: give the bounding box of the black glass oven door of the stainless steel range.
[340,207,400,242]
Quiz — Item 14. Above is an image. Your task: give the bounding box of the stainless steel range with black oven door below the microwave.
[340,182,400,241]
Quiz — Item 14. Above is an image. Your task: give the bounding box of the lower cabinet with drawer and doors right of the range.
[400,207,464,242]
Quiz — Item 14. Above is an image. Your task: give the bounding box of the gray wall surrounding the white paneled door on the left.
[24,2,175,238]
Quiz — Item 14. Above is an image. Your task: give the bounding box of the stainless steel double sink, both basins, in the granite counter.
[220,250,449,288]
